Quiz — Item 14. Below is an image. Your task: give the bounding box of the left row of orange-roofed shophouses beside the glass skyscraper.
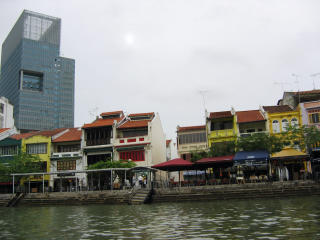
[0,111,166,190]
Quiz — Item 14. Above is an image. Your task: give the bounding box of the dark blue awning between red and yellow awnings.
[233,151,269,166]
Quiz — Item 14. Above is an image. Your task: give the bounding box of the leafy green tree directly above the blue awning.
[237,133,284,154]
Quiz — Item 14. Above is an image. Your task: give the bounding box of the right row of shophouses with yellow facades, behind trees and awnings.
[177,90,320,180]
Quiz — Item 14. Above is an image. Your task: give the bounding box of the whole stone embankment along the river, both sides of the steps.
[0,181,320,206]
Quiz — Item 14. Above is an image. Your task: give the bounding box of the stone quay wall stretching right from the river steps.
[153,181,320,203]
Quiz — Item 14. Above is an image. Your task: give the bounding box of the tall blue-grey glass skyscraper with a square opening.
[0,10,75,131]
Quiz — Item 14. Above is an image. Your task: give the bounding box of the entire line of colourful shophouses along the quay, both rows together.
[0,90,320,190]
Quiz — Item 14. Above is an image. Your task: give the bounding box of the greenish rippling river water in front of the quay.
[0,197,320,240]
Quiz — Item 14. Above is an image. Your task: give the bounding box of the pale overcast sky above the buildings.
[0,0,320,138]
